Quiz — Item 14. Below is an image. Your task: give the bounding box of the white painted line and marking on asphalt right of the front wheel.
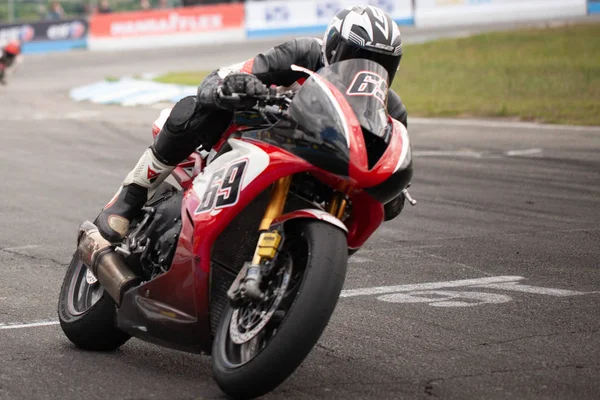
[341,276,598,307]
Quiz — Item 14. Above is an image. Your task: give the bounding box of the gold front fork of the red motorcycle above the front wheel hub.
[227,176,347,306]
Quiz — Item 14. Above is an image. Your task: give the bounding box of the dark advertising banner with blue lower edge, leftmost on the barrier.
[0,19,88,53]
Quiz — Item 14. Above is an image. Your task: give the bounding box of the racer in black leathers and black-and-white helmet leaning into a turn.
[97,6,407,242]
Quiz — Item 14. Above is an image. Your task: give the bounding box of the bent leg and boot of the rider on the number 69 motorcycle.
[97,96,232,242]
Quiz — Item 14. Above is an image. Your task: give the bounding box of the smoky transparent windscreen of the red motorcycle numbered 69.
[273,59,388,175]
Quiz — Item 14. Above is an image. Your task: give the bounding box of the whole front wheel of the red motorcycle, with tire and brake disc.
[212,220,348,398]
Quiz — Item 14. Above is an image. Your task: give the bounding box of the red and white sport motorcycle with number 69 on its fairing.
[59,60,412,397]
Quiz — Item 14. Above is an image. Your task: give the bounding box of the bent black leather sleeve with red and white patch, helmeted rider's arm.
[198,38,321,107]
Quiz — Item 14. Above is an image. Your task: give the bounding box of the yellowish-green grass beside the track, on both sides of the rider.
[157,24,600,125]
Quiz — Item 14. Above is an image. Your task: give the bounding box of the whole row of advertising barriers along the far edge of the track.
[0,0,600,52]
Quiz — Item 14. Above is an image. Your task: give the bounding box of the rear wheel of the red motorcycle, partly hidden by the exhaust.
[58,252,131,351]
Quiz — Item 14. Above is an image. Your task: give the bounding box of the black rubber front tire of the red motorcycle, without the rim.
[212,220,348,398]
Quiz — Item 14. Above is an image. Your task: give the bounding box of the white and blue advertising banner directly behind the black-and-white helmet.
[246,0,413,38]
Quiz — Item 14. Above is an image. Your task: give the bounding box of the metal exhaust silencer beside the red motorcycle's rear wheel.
[77,221,140,306]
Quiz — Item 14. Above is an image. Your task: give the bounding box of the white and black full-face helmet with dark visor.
[323,6,402,84]
